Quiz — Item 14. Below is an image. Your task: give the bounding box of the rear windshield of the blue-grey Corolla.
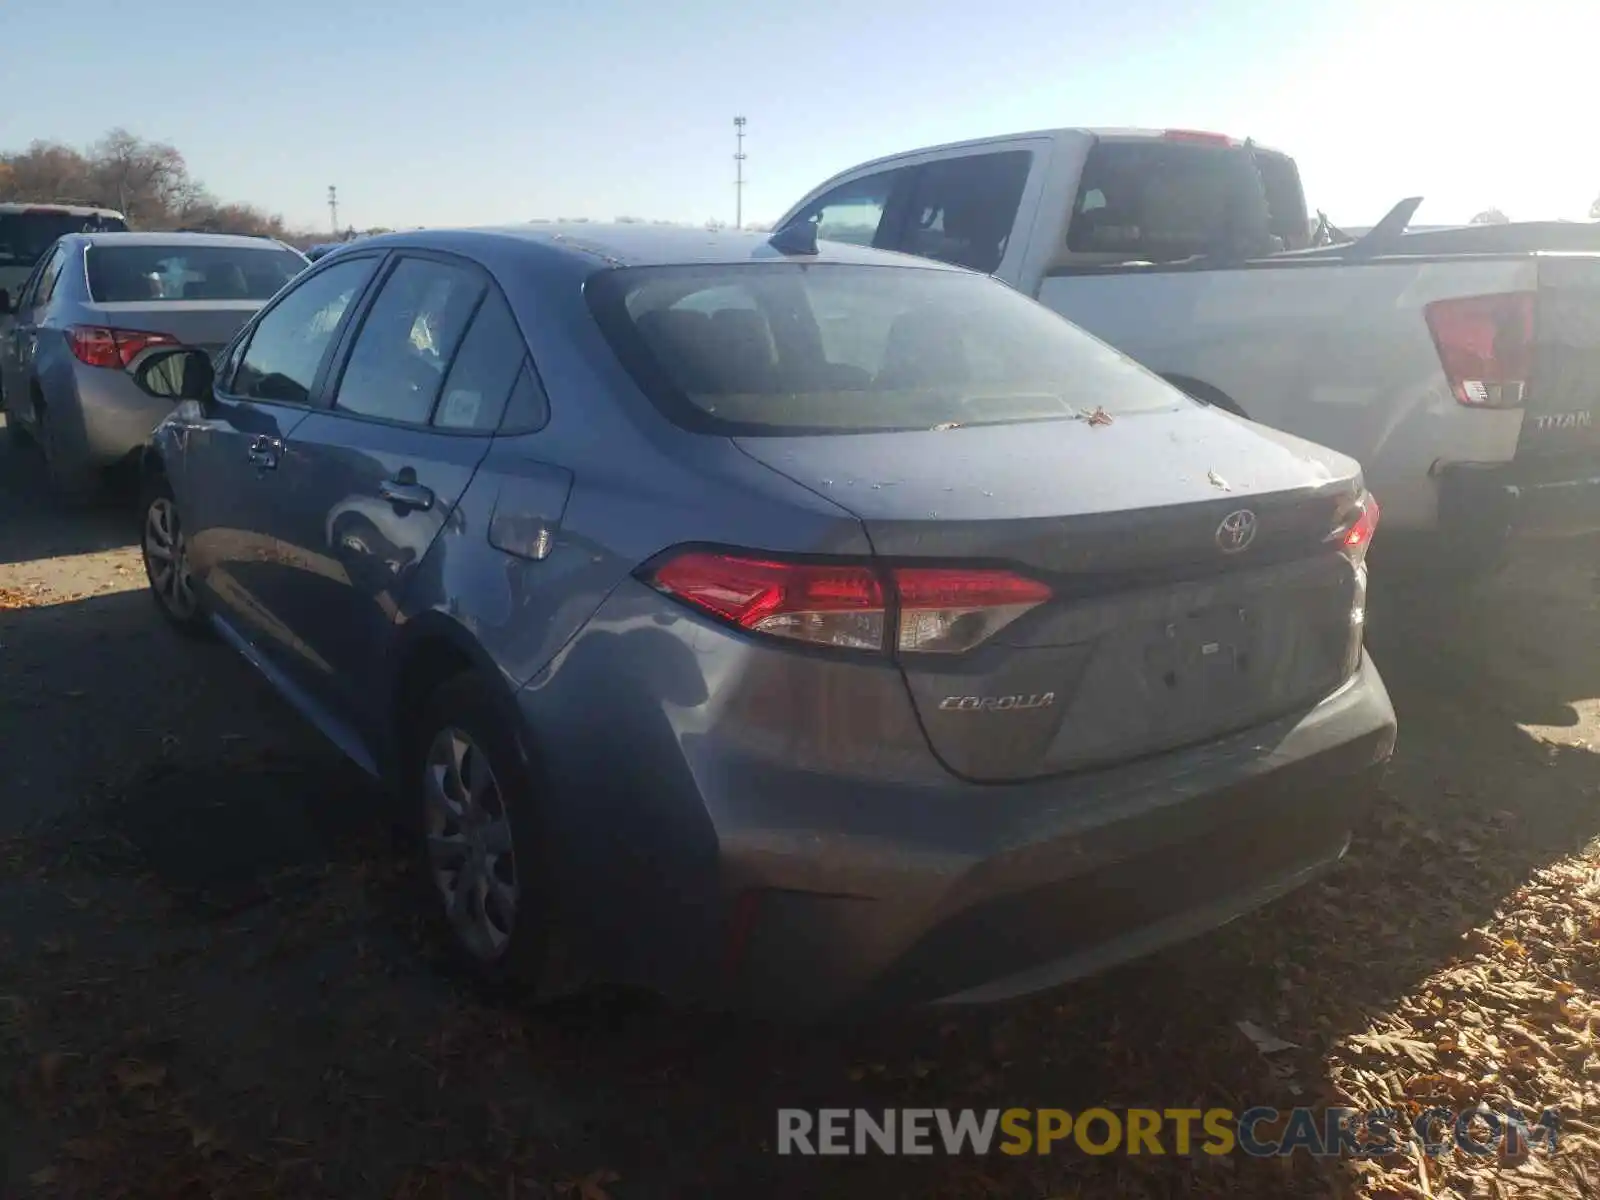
[587,262,1189,435]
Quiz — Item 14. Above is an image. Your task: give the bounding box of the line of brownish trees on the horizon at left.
[0,128,328,246]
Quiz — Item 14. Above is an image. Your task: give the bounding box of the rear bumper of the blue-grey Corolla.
[520,620,1395,1016]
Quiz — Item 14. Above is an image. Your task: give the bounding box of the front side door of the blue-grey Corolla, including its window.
[173,254,381,661]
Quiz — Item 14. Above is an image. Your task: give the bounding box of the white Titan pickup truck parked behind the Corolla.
[779,130,1600,570]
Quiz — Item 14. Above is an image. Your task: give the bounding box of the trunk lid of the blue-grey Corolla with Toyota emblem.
[736,405,1362,782]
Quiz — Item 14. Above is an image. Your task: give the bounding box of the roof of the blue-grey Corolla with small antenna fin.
[341,222,960,270]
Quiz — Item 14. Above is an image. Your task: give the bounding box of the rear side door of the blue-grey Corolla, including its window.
[251,251,512,734]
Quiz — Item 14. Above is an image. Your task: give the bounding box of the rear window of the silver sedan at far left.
[86,245,306,304]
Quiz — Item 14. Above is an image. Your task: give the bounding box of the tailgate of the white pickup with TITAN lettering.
[1517,254,1600,467]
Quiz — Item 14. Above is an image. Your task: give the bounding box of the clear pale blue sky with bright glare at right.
[0,0,1600,235]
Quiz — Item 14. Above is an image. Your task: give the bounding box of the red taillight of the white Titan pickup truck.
[1424,291,1533,408]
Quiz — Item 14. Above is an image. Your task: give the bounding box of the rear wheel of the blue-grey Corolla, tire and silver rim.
[403,674,552,998]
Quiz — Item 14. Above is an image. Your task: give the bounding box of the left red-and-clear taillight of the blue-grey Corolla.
[643,550,1051,654]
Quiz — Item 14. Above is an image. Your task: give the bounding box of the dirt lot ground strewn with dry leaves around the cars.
[0,419,1600,1200]
